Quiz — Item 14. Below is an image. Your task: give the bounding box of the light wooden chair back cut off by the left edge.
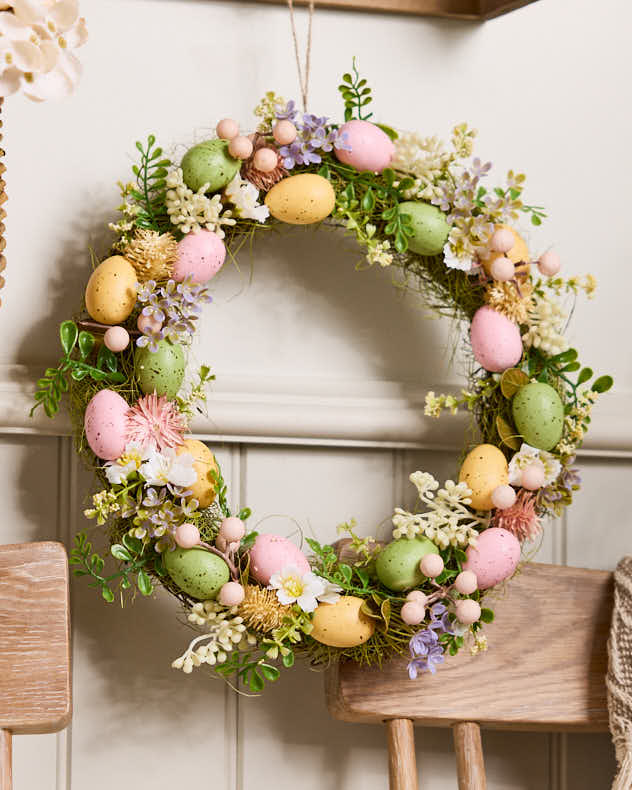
[0,542,71,790]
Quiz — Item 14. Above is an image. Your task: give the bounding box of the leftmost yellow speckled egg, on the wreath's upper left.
[86,255,138,326]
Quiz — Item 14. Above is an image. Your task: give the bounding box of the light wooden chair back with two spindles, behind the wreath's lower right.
[326,563,613,790]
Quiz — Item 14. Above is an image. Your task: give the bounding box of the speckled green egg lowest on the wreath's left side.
[164,548,230,601]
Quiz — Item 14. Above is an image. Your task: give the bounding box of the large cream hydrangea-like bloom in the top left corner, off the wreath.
[0,0,88,101]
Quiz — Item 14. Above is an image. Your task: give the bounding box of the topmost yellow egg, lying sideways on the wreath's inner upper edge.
[266,173,336,225]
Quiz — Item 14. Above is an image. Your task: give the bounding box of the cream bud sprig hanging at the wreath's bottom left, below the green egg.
[171,601,257,675]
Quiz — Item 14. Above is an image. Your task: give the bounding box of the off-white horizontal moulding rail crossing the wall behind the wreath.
[0,365,632,457]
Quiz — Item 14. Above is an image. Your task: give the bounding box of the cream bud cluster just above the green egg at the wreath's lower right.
[392,472,489,549]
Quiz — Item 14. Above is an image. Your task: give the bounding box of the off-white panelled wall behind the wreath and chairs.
[0,0,632,790]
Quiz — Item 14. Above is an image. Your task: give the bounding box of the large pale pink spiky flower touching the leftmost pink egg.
[127,392,186,452]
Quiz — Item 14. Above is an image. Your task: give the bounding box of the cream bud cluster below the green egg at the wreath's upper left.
[165,167,236,239]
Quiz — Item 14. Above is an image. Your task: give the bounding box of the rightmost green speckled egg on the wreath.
[511,382,564,450]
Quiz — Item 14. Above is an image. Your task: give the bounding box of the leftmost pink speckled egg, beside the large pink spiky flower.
[83,390,129,461]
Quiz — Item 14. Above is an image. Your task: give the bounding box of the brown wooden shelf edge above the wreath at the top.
[252,0,535,21]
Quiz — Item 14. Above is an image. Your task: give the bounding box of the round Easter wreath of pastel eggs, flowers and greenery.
[34,63,612,692]
